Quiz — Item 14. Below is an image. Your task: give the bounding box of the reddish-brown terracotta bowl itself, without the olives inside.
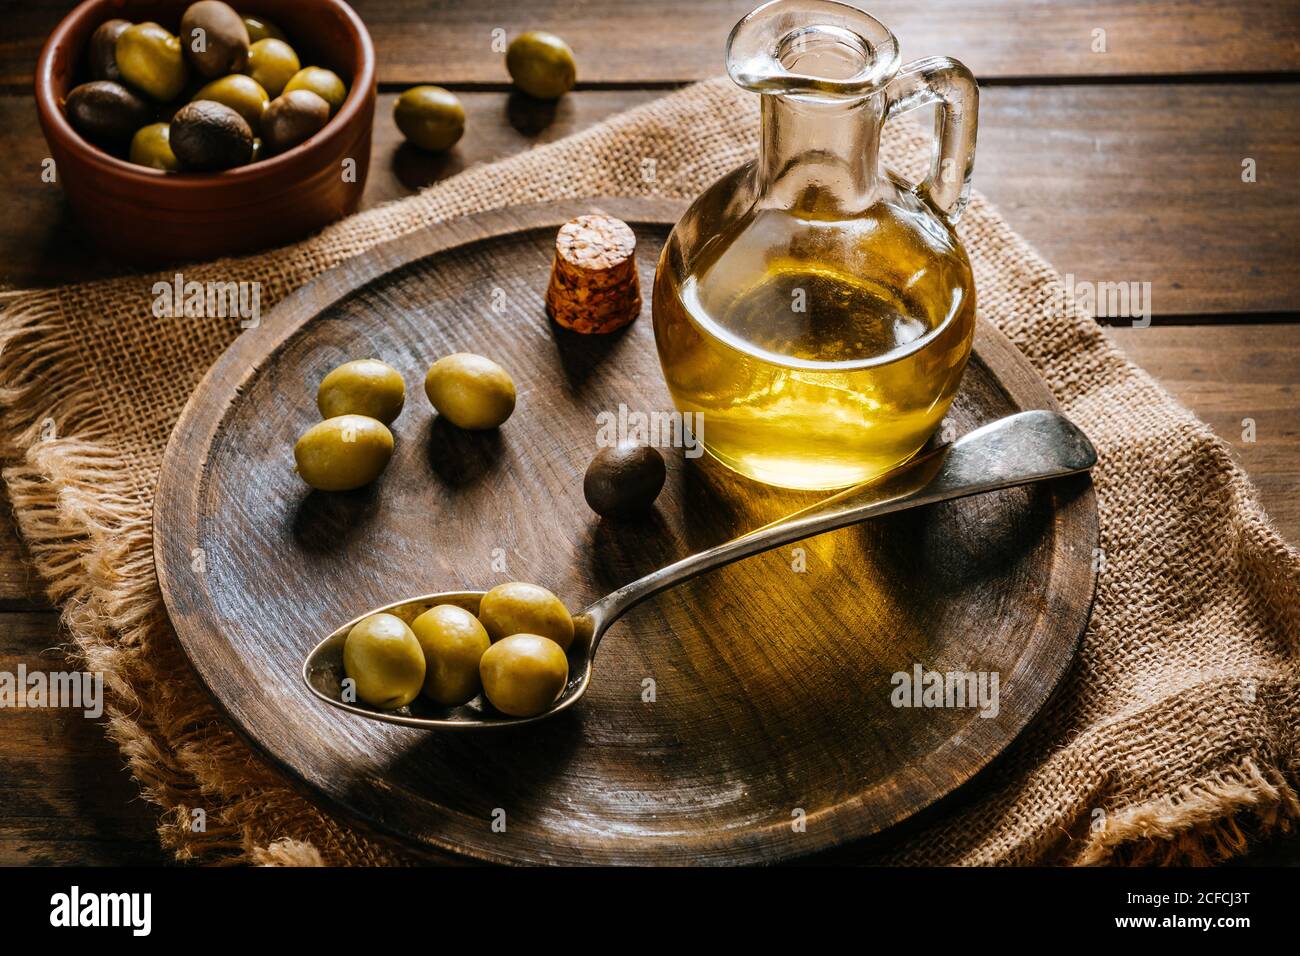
[36,0,376,265]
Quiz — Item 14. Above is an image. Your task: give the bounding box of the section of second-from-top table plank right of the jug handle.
[975,85,1300,316]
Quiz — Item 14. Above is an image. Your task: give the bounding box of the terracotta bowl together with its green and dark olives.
[36,0,376,265]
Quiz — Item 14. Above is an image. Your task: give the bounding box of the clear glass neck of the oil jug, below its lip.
[757,92,884,220]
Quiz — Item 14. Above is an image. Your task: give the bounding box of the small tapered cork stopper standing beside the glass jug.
[546,215,641,334]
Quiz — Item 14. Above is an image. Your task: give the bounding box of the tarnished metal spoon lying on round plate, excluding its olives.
[303,411,1097,730]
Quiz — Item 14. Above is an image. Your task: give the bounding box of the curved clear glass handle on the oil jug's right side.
[885,56,979,224]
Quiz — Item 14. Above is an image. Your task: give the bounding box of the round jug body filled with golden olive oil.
[654,203,975,489]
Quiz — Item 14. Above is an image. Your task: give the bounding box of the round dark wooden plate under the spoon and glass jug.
[155,199,1097,864]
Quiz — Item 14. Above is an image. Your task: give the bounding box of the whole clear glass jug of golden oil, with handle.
[654,0,979,489]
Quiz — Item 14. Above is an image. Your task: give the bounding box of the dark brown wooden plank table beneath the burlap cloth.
[0,0,1300,864]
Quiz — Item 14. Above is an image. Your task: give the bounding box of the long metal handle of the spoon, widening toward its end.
[586,411,1097,636]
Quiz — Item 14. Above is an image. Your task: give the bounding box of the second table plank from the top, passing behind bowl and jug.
[0,85,1300,316]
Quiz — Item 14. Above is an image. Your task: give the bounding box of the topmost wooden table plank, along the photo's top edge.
[0,0,1300,88]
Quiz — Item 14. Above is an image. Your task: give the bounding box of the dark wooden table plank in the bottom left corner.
[0,611,165,866]
